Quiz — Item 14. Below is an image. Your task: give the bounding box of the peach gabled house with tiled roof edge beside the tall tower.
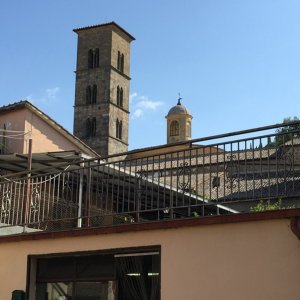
[0,101,97,157]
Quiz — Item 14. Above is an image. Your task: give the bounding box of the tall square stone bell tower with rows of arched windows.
[74,22,134,157]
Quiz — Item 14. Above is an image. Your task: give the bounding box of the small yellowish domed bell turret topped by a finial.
[166,97,193,144]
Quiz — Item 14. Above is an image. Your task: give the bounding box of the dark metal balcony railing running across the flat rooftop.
[0,122,300,235]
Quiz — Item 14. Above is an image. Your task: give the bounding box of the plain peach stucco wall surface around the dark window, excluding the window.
[0,219,300,300]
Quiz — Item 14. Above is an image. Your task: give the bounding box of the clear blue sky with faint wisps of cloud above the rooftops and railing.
[0,0,300,149]
